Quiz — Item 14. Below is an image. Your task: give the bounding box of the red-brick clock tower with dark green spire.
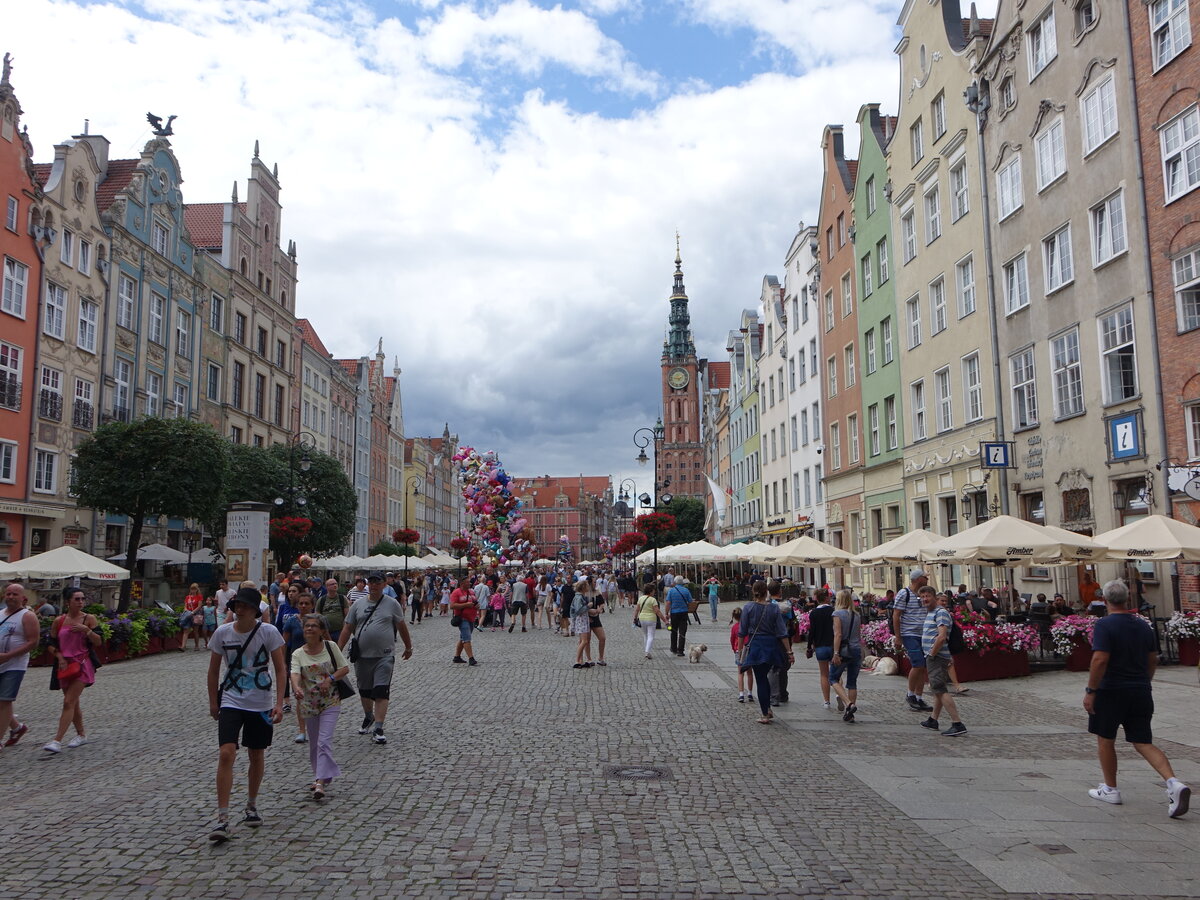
[658,240,704,498]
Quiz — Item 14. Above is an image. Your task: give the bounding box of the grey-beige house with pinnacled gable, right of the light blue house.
[186,143,299,446]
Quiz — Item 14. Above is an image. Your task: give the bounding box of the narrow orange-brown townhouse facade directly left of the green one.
[817,125,863,571]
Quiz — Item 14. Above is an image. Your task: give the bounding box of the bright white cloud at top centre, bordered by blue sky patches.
[420,0,658,96]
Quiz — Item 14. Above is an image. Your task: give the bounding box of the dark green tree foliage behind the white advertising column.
[217,444,358,565]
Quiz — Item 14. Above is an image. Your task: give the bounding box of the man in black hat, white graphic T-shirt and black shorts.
[208,587,287,844]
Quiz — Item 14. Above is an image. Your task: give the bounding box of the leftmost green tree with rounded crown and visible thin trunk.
[71,416,228,612]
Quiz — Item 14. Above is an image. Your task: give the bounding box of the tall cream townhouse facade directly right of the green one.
[888,0,993,592]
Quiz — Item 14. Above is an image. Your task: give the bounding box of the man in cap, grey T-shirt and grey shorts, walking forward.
[337,572,413,744]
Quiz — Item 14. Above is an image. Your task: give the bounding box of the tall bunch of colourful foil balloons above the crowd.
[454,446,536,566]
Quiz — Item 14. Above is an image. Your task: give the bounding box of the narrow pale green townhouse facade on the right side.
[853,103,908,587]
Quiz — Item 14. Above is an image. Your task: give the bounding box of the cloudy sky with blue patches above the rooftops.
[2,0,995,501]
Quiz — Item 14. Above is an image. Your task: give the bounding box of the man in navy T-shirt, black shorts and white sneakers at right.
[1084,581,1192,818]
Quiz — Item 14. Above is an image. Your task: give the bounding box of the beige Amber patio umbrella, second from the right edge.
[919,516,1105,565]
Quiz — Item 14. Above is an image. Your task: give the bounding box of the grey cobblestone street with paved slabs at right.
[0,608,1200,899]
